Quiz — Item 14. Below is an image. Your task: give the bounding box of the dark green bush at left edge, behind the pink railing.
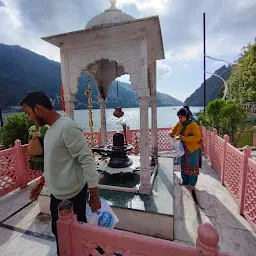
[1,113,34,148]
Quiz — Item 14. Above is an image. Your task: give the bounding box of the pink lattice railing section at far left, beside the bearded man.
[0,140,41,197]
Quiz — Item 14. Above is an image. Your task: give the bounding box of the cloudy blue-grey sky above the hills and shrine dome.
[0,0,256,100]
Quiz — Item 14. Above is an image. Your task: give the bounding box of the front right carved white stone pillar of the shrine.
[139,97,151,194]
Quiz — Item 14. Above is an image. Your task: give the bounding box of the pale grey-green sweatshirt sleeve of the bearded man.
[62,123,99,188]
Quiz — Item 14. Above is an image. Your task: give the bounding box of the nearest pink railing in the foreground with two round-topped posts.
[57,200,232,256]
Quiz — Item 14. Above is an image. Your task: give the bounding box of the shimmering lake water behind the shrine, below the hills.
[3,106,203,131]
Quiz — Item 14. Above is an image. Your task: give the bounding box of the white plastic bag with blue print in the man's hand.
[86,198,119,228]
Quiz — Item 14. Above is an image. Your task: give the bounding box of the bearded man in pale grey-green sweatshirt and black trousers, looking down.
[21,91,101,253]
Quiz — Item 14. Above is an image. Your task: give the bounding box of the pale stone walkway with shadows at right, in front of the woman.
[174,161,256,256]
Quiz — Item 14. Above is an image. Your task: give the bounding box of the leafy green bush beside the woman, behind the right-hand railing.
[198,99,247,146]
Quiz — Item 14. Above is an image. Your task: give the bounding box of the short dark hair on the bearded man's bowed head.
[20,91,53,110]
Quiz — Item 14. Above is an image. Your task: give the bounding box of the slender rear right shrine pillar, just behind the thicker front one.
[150,95,158,164]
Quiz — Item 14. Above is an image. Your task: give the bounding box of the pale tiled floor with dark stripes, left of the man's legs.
[0,184,56,256]
